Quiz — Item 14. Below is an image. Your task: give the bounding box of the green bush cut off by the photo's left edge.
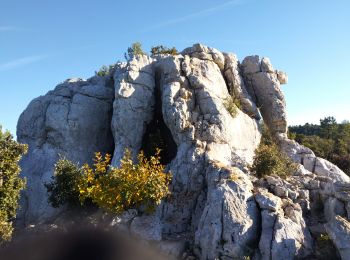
[0,126,27,242]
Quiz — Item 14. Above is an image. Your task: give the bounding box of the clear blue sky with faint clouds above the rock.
[0,0,350,136]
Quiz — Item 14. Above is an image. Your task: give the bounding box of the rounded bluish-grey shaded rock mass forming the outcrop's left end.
[17,77,114,224]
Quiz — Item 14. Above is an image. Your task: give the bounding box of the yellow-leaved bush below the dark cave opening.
[79,149,171,213]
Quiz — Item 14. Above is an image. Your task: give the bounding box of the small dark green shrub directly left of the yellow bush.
[45,158,82,208]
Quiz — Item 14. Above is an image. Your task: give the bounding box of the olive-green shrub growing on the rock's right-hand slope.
[251,124,297,178]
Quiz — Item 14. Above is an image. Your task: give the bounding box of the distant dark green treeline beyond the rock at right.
[289,117,350,175]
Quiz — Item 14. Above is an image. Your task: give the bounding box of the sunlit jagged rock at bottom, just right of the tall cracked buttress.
[255,189,312,259]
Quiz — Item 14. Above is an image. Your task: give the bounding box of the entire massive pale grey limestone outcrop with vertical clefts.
[17,44,350,259]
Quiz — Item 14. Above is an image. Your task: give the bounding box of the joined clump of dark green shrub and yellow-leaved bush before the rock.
[47,150,171,213]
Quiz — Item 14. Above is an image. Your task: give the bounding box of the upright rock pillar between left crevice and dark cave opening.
[112,55,155,166]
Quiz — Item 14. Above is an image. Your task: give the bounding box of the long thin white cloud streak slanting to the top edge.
[144,0,243,31]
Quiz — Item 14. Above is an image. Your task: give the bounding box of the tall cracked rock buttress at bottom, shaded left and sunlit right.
[195,164,260,259]
